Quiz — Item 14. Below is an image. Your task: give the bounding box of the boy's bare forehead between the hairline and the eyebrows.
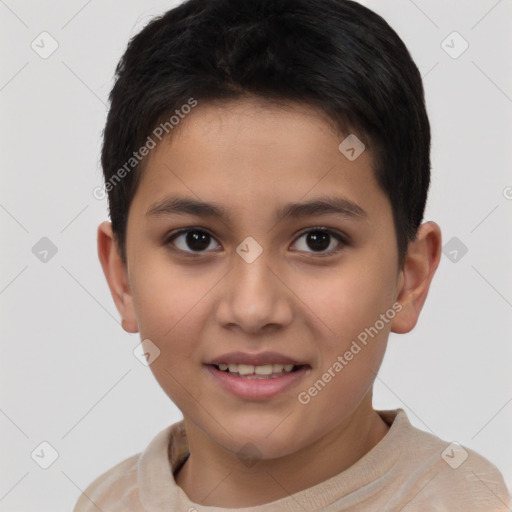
[128,100,386,226]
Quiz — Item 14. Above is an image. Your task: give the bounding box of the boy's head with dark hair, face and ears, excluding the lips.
[98,0,440,458]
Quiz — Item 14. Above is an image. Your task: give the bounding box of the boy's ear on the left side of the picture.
[98,221,139,333]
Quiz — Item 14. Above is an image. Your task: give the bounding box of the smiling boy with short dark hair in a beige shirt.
[75,0,509,512]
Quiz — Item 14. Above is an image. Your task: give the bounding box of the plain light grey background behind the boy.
[0,0,512,512]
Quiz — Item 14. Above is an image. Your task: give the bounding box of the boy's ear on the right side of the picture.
[391,222,441,334]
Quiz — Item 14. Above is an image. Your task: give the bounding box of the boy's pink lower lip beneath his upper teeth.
[205,365,311,400]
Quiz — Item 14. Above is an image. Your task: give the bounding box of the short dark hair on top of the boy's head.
[101,0,430,266]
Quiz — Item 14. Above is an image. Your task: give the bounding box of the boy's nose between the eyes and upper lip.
[216,251,293,334]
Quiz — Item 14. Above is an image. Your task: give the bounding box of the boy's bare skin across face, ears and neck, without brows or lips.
[98,99,441,508]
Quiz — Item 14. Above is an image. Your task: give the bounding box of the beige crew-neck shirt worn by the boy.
[74,409,510,512]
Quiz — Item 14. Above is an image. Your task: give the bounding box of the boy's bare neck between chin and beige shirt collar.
[175,395,389,508]
